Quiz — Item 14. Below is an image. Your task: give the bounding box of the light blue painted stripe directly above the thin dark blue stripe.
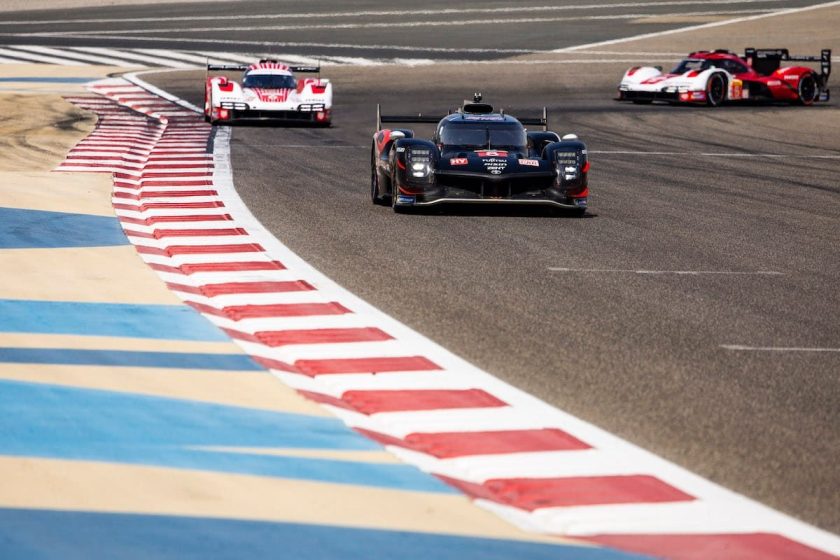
[0,299,230,342]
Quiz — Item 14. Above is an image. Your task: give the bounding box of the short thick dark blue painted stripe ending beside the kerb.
[0,207,128,249]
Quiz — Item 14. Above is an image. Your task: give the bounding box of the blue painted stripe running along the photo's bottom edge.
[0,509,652,560]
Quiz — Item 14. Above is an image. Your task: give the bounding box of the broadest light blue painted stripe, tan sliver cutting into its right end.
[0,380,455,493]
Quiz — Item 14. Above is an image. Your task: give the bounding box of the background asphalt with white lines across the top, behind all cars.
[0,0,828,59]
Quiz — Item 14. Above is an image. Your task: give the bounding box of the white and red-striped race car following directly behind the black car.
[204,59,332,126]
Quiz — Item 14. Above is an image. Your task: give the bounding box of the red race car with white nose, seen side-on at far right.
[618,48,831,107]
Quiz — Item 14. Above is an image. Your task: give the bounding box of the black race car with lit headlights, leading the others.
[370,94,589,214]
